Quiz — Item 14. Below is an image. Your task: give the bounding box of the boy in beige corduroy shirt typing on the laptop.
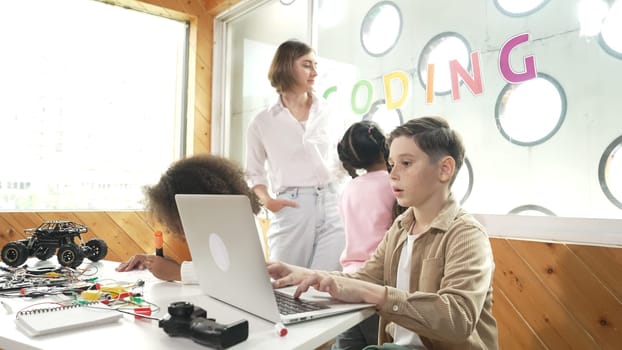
[268,117,498,349]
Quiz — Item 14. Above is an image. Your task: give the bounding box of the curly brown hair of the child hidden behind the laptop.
[144,154,260,239]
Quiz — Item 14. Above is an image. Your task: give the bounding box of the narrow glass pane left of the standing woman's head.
[212,1,311,165]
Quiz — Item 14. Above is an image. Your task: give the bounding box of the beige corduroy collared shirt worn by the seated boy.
[347,197,498,350]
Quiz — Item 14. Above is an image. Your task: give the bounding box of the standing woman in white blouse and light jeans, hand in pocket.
[245,40,344,270]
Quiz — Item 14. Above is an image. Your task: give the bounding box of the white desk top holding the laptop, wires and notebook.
[0,259,373,350]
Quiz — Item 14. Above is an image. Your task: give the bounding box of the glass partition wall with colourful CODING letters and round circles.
[213,0,622,244]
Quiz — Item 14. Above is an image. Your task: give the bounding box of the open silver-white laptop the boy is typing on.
[175,194,373,324]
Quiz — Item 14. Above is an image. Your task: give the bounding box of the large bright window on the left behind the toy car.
[0,0,188,211]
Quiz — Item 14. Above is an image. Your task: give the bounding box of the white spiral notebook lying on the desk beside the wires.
[15,302,123,337]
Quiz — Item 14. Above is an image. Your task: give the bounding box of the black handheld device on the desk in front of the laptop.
[158,301,248,349]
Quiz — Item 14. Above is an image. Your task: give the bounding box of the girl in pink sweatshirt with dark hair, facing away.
[333,121,395,350]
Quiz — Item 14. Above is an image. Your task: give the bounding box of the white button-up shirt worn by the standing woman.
[245,95,344,192]
